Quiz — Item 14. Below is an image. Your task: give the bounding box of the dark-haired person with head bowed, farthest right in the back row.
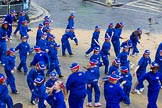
[130,28,142,56]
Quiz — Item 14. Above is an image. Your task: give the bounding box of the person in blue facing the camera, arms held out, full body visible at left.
[15,36,30,75]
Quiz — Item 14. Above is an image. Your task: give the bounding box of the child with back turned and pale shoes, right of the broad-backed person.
[86,59,101,107]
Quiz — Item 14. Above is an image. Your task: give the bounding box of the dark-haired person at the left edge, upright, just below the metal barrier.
[0,21,9,66]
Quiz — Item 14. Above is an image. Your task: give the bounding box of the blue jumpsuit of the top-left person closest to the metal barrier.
[4,14,15,38]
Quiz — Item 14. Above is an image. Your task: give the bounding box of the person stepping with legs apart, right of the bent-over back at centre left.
[46,43,64,78]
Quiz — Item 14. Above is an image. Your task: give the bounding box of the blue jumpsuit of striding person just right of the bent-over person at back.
[86,31,100,55]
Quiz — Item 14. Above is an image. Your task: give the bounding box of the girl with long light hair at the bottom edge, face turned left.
[44,81,67,108]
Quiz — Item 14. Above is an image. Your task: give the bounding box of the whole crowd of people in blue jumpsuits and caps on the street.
[0,10,162,108]
